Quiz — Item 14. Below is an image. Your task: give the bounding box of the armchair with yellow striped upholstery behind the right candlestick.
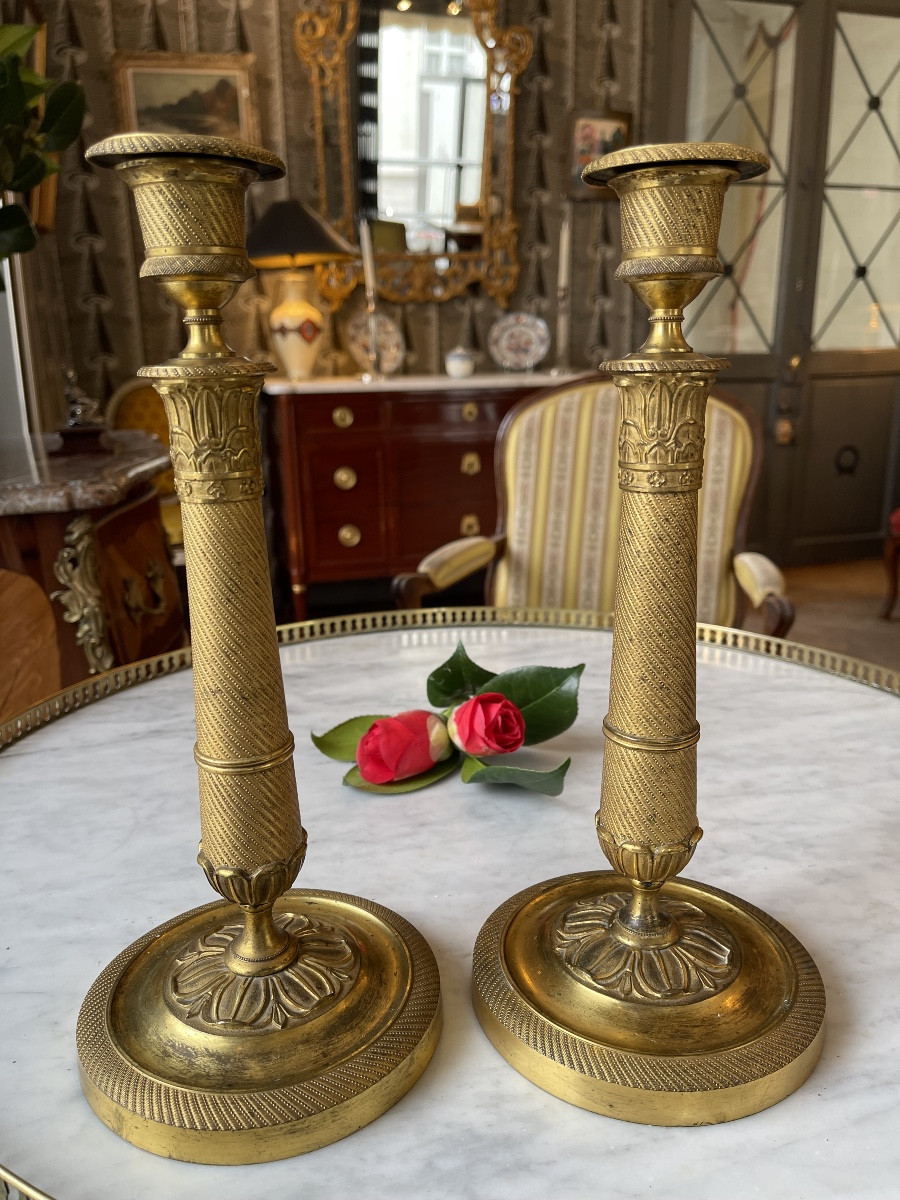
[394,376,793,636]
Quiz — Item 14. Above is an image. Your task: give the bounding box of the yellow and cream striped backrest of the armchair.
[491,380,754,625]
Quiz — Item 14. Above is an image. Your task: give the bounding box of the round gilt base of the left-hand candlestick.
[78,889,440,1164]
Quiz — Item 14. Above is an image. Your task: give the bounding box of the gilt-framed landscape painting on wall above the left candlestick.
[113,52,259,142]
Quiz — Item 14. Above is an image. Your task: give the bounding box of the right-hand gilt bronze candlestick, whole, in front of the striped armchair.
[474,143,824,1124]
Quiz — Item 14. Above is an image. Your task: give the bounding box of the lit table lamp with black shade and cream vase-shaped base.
[247,200,359,379]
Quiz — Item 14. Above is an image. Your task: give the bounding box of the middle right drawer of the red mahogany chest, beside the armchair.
[391,437,494,506]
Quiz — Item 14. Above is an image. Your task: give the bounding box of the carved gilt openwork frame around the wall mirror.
[300,0,533,312]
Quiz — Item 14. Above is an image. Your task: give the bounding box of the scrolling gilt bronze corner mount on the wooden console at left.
[50,516,115,674]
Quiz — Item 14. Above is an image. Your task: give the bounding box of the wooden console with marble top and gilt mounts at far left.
[0,431,185,688]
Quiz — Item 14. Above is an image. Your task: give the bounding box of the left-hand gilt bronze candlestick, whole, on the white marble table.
[78,133,440,1163]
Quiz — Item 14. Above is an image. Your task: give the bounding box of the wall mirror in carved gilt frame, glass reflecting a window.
[294,0,532,310]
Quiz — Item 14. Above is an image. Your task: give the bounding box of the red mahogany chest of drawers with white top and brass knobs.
[263,374,580,620]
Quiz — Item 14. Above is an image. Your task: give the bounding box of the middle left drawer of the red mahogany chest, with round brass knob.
[301,437,384,516]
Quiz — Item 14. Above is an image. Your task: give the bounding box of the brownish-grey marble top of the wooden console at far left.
[0,430,170,516]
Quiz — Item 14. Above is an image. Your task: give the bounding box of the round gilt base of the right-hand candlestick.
[474,871,824,1126]
